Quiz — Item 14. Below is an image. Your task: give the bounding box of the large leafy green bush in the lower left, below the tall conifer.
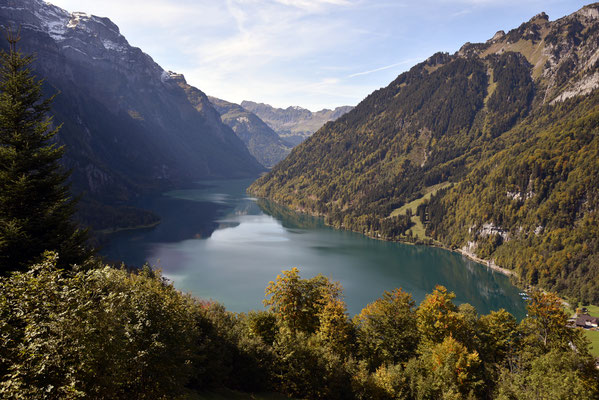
[0,254,196,399]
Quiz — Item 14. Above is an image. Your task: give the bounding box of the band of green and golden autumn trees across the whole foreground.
[0,264,599,400]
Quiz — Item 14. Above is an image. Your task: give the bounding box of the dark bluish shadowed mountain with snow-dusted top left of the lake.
[0,0,263,228]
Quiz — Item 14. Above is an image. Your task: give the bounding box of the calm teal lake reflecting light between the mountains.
[103,180,525,318]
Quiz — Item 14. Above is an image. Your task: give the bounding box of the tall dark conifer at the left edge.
[0,32,90,273]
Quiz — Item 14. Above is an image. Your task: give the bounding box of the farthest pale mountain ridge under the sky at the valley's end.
[241,100,353,146]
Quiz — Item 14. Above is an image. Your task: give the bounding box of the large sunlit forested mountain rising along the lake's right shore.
[250,3,599,302]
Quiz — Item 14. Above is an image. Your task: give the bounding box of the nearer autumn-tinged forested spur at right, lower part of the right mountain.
[419,93,599,303]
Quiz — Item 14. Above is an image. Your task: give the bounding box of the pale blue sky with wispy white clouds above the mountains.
[49,0,590,111]
